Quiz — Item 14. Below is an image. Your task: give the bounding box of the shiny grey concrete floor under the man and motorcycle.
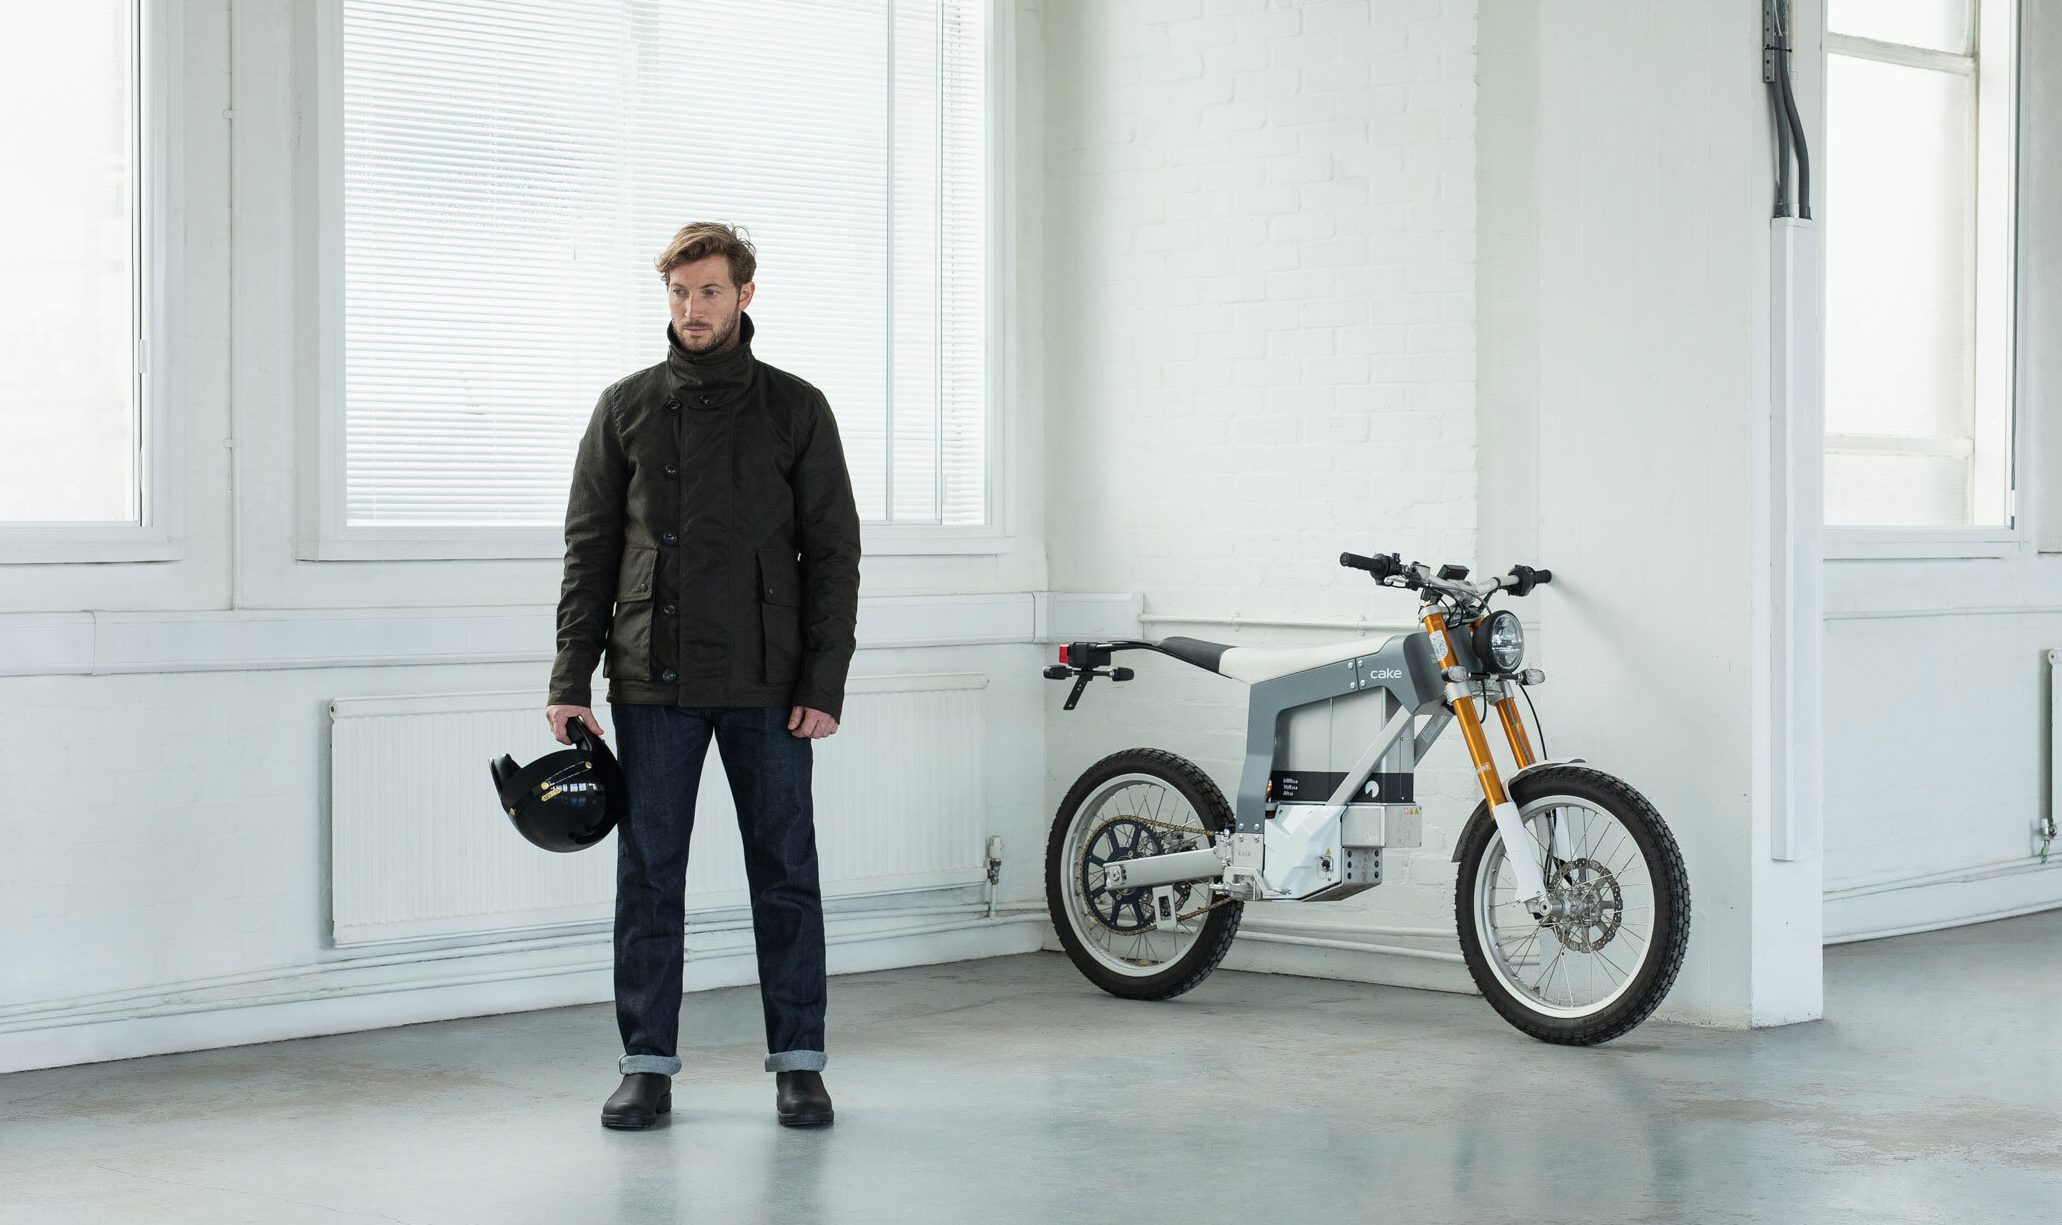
[0,914,2062,1225]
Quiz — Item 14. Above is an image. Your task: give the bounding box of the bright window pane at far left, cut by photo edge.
[0,0,169,544]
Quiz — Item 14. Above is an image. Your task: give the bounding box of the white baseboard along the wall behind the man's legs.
[0,907,1047,1072]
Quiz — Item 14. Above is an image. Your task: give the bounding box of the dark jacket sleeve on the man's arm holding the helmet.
[548,392,629,705]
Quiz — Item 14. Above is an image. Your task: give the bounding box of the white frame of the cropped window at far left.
[0,0,186,565]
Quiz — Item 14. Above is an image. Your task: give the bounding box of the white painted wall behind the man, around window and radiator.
[0,0,1045,1070]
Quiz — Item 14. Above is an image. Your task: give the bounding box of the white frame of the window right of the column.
[1821,0,2035,561]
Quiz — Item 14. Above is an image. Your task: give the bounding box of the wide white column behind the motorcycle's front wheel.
[1481,0,1823,1027]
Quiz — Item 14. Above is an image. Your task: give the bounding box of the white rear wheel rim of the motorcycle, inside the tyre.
[1060,773,1210,978]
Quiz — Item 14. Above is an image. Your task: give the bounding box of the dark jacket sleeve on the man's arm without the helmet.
[794,392,860,720]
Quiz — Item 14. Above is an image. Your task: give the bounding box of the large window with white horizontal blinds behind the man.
[324,0,990,555]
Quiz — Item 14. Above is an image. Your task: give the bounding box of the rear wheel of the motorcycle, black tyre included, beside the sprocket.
[1045,749,1241,1000]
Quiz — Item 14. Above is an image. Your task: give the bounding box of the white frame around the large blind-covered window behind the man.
[295,0,1017,561]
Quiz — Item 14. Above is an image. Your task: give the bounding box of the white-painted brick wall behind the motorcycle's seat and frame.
[1041,0,1487,949]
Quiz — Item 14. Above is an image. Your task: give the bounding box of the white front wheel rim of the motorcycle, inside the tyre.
[1474,796,1656,1021]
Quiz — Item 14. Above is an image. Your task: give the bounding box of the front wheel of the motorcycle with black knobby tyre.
[1454,765,1689,1046]
